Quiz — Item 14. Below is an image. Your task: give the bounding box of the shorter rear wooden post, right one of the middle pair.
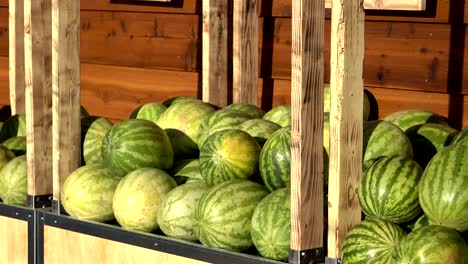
[233,0,258,105]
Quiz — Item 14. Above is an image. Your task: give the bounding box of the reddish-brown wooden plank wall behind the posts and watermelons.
[0,0,468,128]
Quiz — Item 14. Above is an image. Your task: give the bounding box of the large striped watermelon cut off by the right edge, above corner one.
[418,144,468,232]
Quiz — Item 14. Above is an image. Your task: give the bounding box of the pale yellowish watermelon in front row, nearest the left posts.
[61,163,122,222]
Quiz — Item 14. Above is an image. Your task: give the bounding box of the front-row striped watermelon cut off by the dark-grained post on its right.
[250,188,291,260]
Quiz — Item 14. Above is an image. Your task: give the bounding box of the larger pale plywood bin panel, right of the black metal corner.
[44,226,206,264]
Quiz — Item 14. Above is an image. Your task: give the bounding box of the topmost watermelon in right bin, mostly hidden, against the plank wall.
[383,109,448,132]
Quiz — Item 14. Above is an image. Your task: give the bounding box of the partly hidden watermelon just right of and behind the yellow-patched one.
[237,119,281,146]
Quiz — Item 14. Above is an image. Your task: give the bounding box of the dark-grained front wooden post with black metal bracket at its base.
[290,0,325,263]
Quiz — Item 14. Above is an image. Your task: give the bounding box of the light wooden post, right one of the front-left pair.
[52,0,81,212]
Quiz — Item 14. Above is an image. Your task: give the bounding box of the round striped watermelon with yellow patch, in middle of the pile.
[199,129,261,186]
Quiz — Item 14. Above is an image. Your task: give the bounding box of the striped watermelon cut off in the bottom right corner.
[391,225,468,264]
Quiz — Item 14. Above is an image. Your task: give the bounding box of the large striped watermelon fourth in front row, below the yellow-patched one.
[195,180,268,252]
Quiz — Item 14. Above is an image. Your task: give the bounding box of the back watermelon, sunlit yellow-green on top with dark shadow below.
[156,100,215,159]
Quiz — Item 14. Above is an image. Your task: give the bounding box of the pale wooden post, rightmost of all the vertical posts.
[328,0,364,259]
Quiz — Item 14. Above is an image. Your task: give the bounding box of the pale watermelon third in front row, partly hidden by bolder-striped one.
[158,182,209,241]
